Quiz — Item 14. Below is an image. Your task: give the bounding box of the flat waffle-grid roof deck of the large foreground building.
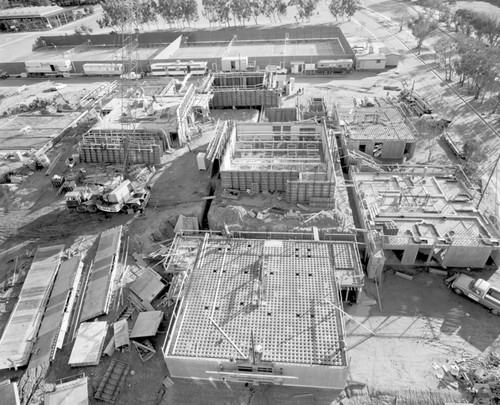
[165,235,350,367]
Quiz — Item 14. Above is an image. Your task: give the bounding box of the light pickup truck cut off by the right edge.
[445,273,500,316]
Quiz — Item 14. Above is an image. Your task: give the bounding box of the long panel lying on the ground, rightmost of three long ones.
[80,226,122,321]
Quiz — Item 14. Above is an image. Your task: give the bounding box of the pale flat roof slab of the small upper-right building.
[337,107,416,140]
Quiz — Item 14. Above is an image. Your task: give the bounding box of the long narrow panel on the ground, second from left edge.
[28,256,82,368]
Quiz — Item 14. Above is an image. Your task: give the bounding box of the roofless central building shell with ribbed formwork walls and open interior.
[220,122,338,207]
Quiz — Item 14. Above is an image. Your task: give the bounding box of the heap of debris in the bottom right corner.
[432,352,500,404]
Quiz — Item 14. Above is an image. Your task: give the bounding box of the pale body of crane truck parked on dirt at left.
[97,180,151,212]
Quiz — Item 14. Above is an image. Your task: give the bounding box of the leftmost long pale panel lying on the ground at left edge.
[0,245,64,370]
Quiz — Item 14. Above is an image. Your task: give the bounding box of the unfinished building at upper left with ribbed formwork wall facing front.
[79,79,212,165]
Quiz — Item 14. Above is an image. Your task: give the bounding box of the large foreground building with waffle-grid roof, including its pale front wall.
[163,234,361,392]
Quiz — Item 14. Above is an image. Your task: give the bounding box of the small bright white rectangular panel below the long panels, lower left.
[68,322,108,367]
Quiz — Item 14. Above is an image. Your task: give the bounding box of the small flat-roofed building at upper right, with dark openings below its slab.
[332,105,418,161]
